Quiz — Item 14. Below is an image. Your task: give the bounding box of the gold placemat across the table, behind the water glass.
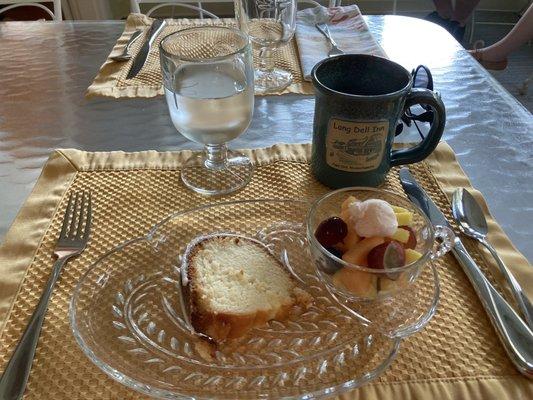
[85,14,313,98]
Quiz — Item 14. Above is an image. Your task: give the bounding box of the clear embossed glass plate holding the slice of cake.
[70,200,432,399]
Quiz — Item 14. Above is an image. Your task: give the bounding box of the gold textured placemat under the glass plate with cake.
[0,143,533,400]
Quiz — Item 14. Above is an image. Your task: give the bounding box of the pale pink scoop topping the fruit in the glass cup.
[348,199,398,237]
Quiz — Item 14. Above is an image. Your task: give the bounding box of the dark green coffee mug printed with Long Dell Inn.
[311,54,446,188]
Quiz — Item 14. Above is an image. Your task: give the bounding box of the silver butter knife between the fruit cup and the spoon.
[400,168,533,379]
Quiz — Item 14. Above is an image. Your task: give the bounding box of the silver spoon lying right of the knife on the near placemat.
[452,188,533,329]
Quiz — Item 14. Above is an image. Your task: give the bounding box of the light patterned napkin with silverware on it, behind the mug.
[296,5,387,81]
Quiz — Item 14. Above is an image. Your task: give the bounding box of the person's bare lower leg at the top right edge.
[478,5,533,61]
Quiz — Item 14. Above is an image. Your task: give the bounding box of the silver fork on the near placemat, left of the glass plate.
[0,192,92,400]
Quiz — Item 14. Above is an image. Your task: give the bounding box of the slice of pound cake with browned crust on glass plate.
[185,234,311,342]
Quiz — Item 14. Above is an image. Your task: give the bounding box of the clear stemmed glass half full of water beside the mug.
[160,26,254,195]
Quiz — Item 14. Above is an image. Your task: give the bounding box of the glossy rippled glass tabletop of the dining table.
[0,15,533,261]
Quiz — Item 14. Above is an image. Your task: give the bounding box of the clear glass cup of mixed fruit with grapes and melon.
[307,187,454,304]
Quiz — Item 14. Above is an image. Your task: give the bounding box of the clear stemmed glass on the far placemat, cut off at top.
[235,0,296,93]
